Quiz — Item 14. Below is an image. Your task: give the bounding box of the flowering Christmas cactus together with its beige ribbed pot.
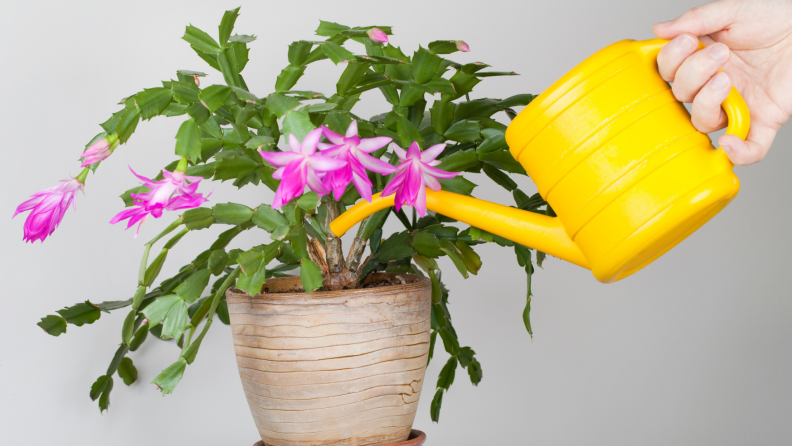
[14,8,552,445]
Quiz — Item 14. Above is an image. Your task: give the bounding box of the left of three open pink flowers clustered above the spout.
[259,128,347,209]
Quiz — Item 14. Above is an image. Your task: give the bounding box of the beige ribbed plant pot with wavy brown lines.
[226,273,431,446]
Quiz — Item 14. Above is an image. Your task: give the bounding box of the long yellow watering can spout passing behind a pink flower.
[330,189,590,269]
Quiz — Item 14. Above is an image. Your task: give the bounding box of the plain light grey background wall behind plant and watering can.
[0,0,792,445]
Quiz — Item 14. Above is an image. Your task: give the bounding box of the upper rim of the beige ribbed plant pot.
[226,272,432,300]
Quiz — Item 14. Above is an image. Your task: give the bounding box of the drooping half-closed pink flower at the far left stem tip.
[11,178,85,243]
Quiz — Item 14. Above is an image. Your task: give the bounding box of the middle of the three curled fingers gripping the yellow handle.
[671,43,730,102]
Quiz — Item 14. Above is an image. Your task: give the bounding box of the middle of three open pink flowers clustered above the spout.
[319,121,396,201]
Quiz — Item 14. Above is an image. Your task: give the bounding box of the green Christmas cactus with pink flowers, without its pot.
[20,8,552,421]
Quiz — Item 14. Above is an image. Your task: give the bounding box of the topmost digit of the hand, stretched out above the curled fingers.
[652,0,734,39]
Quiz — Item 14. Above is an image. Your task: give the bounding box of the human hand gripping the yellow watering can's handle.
[652,0,792,166]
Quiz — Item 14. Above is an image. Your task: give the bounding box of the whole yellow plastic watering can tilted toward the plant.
[330,39,750,283]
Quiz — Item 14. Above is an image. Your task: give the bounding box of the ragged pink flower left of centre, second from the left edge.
[110,167,211,237]
